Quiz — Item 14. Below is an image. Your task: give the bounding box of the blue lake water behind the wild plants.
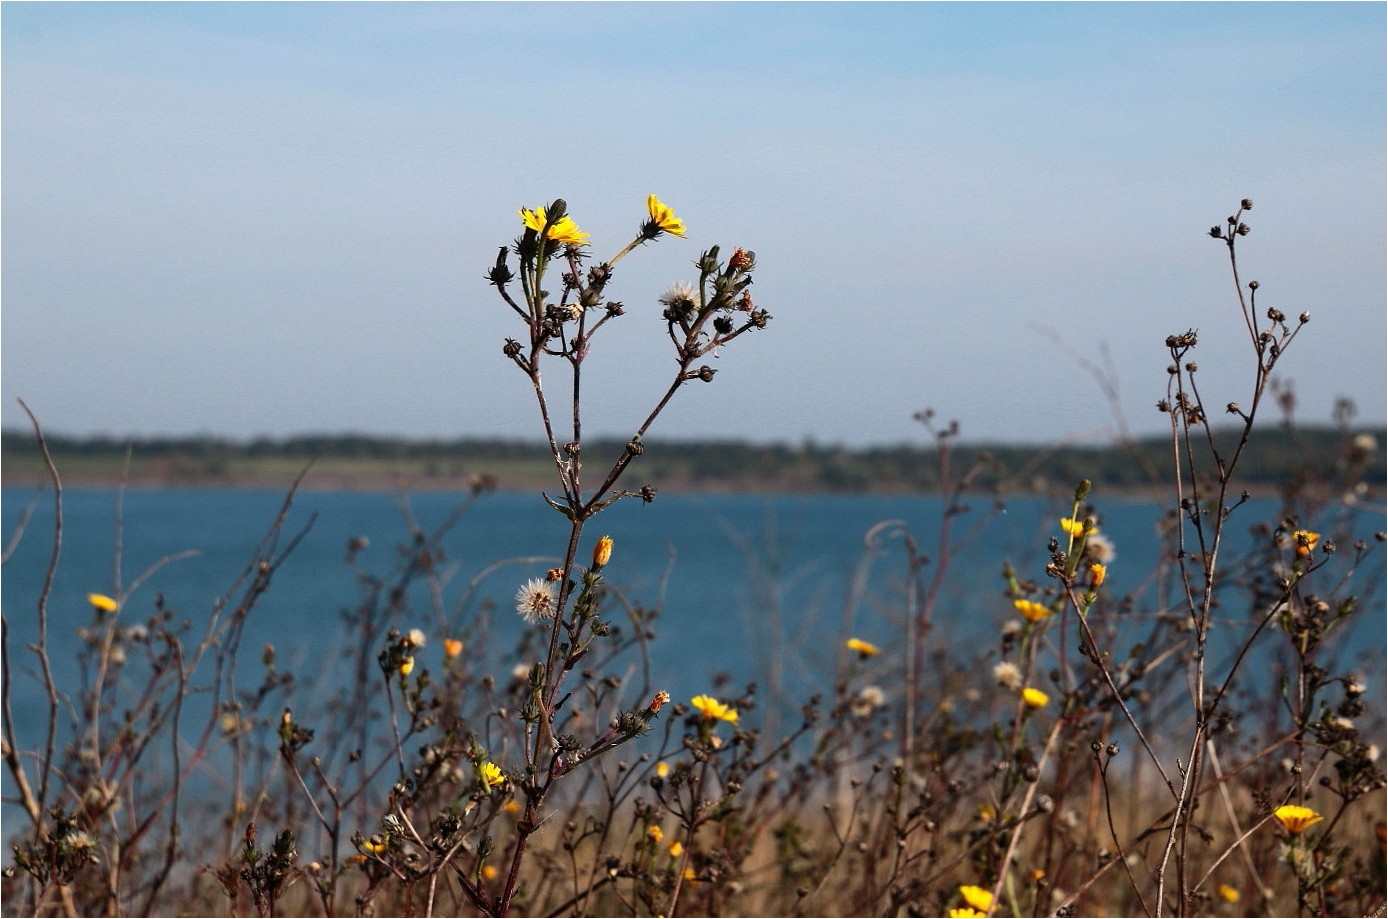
[3,487,1388,838]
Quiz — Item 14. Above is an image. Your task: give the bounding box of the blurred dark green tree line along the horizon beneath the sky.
[0,425,1388,491]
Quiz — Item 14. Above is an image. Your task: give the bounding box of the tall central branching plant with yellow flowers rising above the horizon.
[487,194,770,915]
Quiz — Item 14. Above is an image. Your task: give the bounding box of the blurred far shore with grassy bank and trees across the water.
[0,428,1385,501]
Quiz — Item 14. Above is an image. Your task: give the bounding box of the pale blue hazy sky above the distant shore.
[0,1,1388,447]
